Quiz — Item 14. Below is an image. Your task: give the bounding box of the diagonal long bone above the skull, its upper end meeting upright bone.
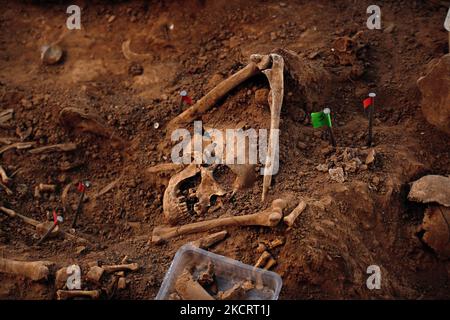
[167,54,271,132]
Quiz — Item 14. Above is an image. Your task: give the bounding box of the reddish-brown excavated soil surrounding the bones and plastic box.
[0,0,450,299]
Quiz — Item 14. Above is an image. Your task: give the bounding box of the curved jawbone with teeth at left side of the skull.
[163,163,200,225]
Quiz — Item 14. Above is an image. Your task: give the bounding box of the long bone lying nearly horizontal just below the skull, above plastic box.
[152,199,287,243]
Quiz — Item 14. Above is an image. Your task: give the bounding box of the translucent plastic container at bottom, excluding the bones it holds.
[155,244,282,300]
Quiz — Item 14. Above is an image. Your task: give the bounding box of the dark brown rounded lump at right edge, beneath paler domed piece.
[422,206,450,260]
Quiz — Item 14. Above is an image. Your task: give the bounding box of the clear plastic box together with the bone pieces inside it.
[155,244,282,300]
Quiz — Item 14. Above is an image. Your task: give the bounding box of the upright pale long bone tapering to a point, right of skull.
[262,53,284,201]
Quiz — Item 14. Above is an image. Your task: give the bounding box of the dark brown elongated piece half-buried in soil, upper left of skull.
[59,107,125,148]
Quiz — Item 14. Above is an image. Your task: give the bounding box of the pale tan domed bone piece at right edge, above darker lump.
[408,175,450,207]
